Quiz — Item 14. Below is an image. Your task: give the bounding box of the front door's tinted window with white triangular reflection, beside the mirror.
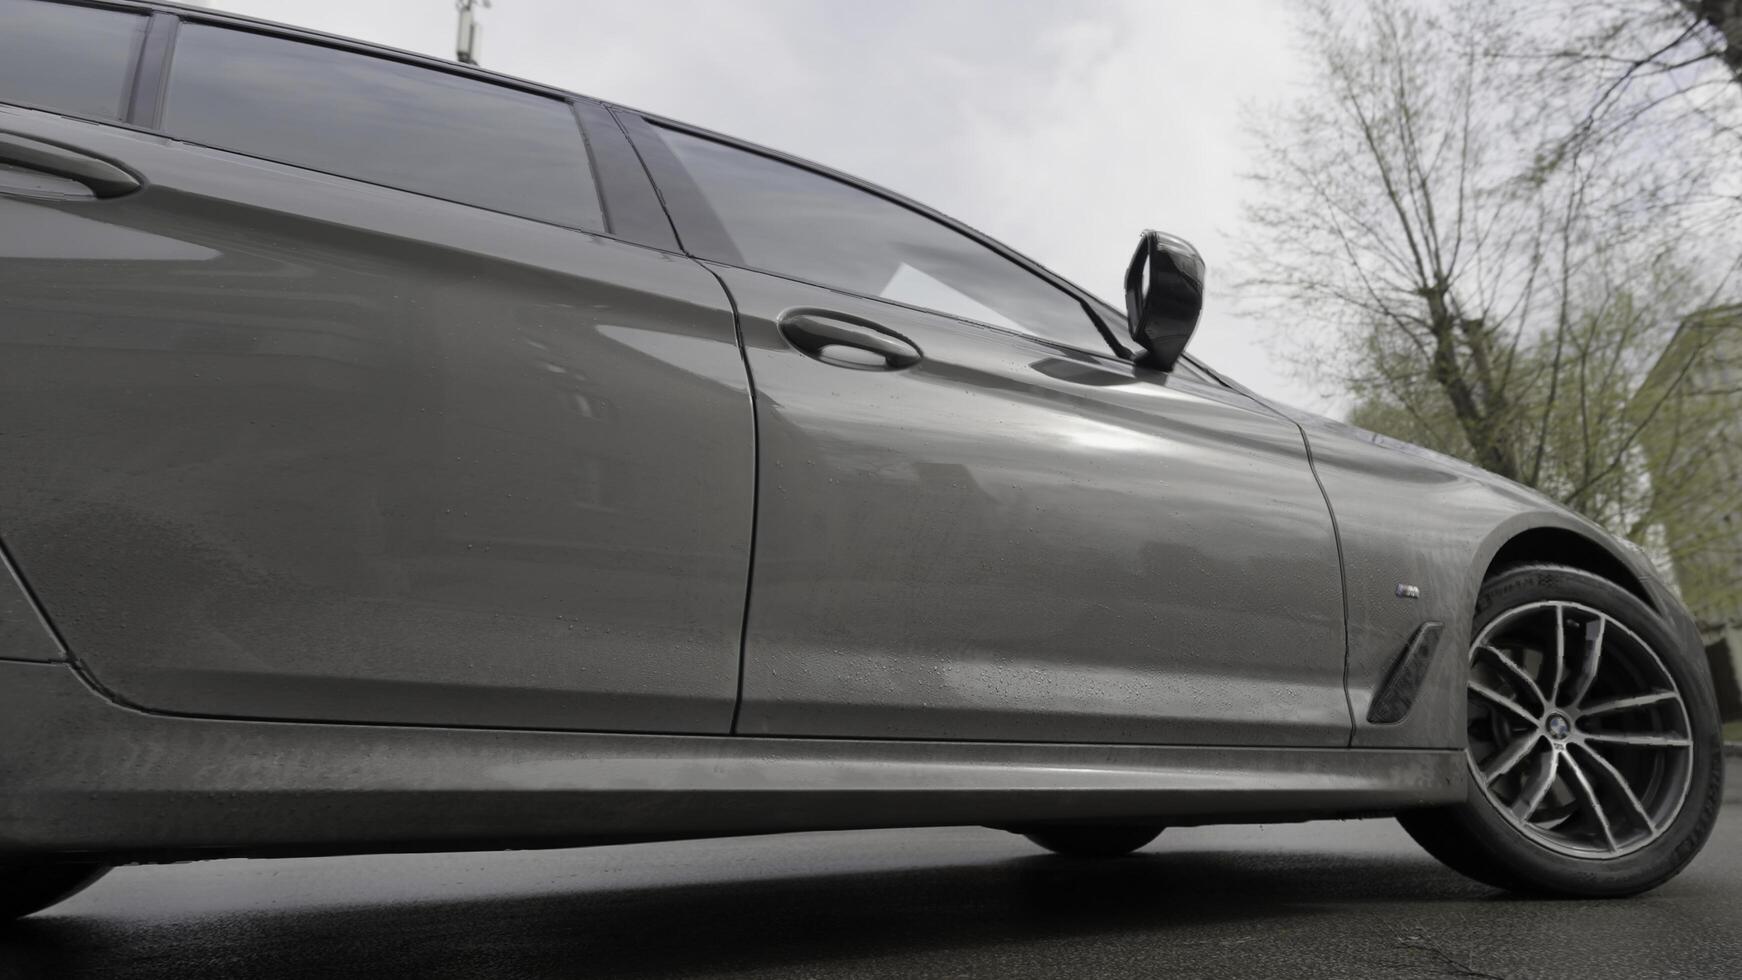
[660,131,1103,348]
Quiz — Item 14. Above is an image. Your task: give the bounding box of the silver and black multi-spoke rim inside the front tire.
[1469,602,1693,858]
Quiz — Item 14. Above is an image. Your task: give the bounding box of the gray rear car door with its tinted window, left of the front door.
[0,3,754,733]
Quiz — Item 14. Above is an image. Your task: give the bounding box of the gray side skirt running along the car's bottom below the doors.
[0,663,1467,862]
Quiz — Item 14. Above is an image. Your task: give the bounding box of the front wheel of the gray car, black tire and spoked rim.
[1399,564,1725,898]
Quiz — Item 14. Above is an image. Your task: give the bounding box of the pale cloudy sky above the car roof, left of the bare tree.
[209,0,1338,411]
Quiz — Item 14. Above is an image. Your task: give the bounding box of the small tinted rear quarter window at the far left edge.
[0,0,145,120]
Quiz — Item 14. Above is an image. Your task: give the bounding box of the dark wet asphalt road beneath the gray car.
[0,759,1742,980]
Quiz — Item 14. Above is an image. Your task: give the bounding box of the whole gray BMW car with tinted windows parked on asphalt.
[0,0,1723,916]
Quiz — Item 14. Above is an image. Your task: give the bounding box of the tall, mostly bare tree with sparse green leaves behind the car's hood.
[1242,0,1742,563]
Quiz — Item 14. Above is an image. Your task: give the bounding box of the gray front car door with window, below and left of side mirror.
[631,120,1350,745]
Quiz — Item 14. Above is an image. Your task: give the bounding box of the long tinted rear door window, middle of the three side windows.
[164,24,604,230]
